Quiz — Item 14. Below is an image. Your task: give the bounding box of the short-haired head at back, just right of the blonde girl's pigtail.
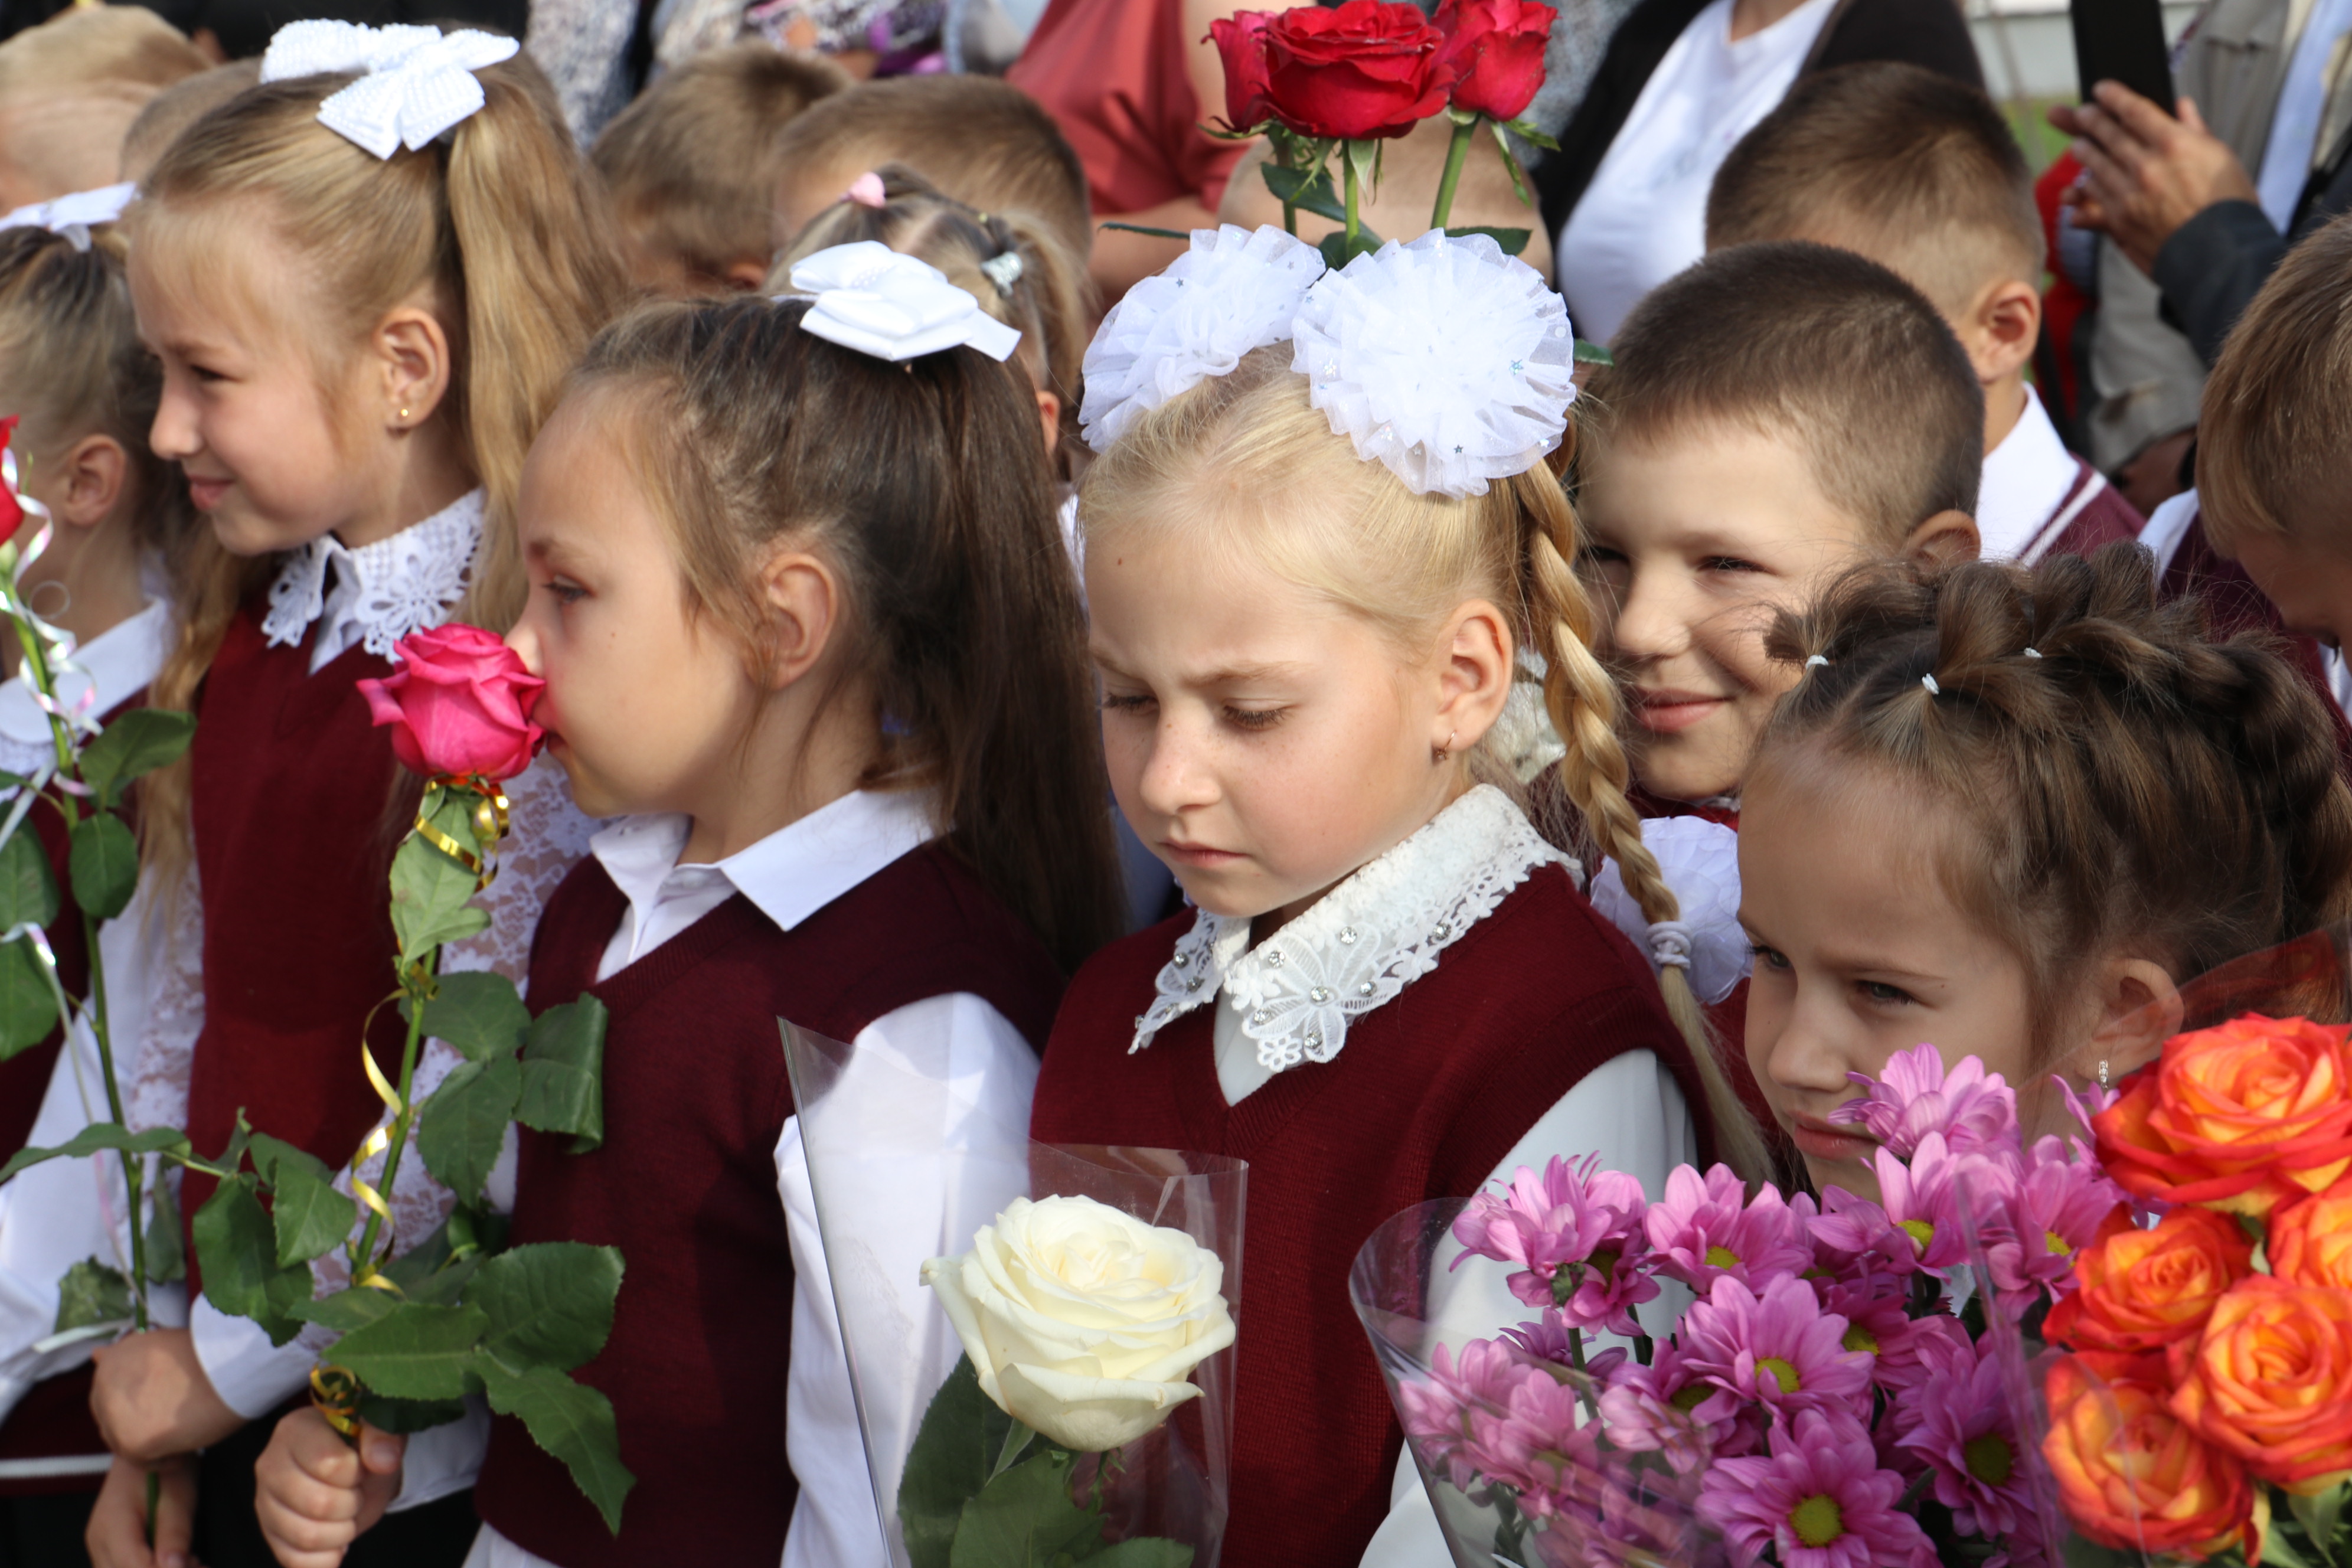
[588,40,849,299]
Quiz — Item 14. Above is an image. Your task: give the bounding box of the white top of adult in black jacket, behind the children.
[1552,0,1835,343]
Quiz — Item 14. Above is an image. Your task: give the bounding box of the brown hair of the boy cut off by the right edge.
[2197,216,2352,550]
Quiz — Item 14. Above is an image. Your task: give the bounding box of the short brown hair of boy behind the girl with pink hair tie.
[776,75,1094,256]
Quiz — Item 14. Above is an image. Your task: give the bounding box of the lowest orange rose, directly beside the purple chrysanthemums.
[2041,1352,2268,1563]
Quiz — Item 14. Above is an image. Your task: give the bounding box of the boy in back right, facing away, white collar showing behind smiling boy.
[1707,61,2140,564]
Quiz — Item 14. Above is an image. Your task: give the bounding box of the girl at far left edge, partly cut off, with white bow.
[0,191,191,1556]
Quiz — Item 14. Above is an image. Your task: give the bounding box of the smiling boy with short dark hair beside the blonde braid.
[1576,242,1985,816]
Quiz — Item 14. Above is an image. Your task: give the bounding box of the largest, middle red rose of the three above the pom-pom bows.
[1260,0,1453,141]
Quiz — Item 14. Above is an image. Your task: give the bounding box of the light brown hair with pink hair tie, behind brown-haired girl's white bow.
[767,165,1087,472]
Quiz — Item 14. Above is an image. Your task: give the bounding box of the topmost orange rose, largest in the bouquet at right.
[2091,1013,2352,1216]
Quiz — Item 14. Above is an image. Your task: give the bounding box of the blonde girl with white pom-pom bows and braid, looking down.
[1030,226,1757,1568]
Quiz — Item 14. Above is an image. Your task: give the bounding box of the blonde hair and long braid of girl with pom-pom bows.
[1080,343,1771,1180]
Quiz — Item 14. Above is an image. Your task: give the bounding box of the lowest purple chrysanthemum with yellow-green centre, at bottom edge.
[1698,1410,1936,1568]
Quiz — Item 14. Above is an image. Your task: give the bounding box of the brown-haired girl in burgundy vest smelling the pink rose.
[248,270,1117,1568]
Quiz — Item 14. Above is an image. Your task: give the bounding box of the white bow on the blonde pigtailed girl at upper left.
[261,21,522,158]
